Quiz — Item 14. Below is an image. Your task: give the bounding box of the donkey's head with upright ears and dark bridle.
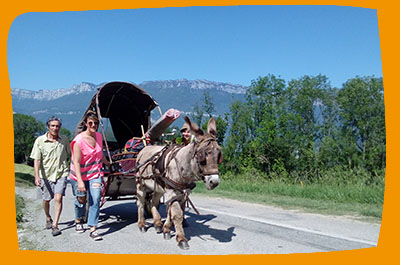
[184,116,222,190]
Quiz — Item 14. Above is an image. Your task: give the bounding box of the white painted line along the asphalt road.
[196,206,377,247]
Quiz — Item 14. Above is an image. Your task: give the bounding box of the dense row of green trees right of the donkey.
[221,75,386,183]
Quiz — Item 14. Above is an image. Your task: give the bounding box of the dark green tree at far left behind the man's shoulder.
[13,114,46,163]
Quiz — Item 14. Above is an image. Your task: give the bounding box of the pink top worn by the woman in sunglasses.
[70,132,104,181]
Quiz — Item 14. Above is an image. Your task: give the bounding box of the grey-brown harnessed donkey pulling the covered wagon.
[136,116,222,249]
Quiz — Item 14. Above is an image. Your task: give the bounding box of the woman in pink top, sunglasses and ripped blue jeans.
[70,112,109,240]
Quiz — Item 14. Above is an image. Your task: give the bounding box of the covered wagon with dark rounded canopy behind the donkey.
[75,82,162,205]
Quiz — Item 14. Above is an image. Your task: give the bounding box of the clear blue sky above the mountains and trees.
[7,6,382,90]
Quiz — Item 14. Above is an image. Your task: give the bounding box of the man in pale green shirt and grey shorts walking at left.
[31,116,71,236]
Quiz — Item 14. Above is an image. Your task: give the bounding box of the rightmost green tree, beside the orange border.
[338,77,386,172]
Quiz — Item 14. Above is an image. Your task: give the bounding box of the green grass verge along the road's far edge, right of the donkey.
[194,173,384,221]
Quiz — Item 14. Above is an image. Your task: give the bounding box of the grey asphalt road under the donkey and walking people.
[16,186,380,255]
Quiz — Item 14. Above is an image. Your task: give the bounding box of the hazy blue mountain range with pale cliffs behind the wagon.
[11,79,247,132]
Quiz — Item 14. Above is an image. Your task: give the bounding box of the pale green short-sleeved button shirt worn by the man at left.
[31,133,71,182]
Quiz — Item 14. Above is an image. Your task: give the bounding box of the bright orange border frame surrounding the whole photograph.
[0,0,400,265]
